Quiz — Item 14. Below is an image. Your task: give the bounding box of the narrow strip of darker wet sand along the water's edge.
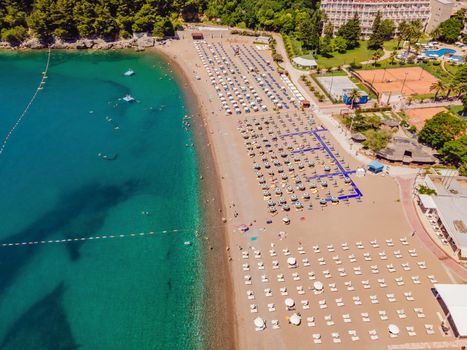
[157,50,236,349]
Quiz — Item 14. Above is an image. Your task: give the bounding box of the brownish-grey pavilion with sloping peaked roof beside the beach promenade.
[376,137,436,164]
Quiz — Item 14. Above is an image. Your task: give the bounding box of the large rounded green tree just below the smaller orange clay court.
[418,112,467,149]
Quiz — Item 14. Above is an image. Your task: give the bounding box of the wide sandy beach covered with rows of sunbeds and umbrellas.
[157,30,460,349]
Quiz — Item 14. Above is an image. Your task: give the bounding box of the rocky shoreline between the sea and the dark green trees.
[0,35,166,51]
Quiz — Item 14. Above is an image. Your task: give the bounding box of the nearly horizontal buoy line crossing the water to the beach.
[0,225,228,248]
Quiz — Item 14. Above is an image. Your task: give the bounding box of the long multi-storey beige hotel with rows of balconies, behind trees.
[321,0,434,36]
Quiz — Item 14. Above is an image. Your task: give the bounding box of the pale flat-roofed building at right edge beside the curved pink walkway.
[418,175,467,259]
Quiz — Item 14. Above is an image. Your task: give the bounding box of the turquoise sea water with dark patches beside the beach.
[0,51,202,350]
